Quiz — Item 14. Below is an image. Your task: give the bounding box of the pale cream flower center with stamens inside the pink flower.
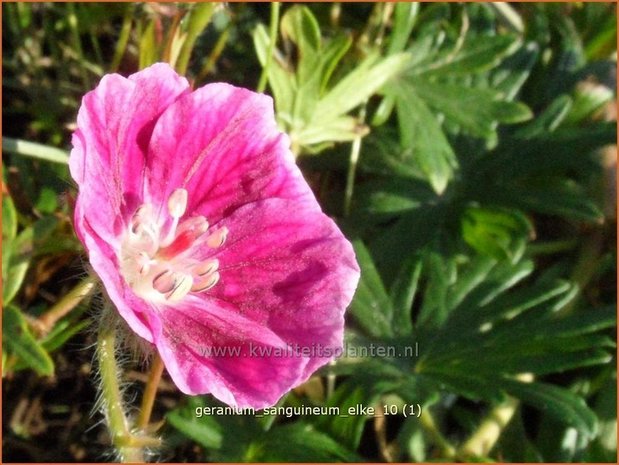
[120,189,228,303]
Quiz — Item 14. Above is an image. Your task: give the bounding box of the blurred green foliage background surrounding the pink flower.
[2,3,617,462]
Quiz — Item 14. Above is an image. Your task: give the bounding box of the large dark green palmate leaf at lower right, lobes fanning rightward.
[402,246,615,434]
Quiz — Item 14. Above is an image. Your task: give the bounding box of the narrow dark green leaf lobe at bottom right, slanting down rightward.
[497,379,598,437]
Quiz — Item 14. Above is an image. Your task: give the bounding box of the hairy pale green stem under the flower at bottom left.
[97,327,144,463]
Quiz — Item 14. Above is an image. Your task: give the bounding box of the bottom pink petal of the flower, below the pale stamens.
[156,298,307,409]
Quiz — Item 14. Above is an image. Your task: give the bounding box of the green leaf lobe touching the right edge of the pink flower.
[350,240,393,337]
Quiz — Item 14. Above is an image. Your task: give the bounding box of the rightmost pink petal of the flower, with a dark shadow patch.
[209,199,359,380]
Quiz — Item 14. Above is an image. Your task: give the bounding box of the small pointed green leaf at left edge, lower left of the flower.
[2,305,54,376]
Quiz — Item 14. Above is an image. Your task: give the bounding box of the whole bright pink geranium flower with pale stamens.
[70,64,359,408]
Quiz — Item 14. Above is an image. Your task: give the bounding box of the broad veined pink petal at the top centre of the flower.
[146,83,314,223]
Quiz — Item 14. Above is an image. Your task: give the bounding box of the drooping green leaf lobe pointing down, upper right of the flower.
[385,82,458,194]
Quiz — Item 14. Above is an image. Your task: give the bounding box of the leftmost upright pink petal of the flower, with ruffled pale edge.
[69,64,189,244]
